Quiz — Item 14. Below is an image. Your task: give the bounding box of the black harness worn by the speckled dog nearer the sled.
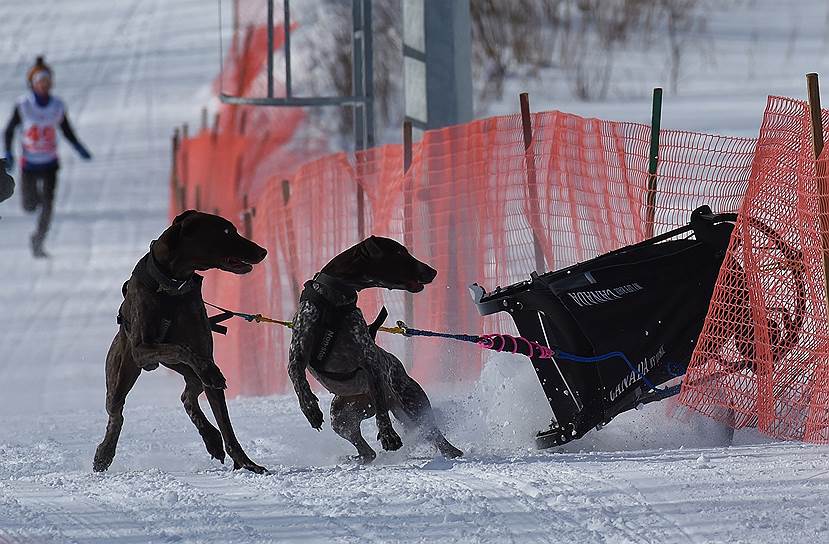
[299,272,388,374]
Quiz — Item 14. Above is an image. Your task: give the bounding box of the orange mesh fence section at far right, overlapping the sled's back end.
[680,97,829,443]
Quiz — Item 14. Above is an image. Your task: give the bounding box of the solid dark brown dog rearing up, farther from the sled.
[93,210,267,473]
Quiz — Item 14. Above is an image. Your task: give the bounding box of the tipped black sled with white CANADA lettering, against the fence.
[470,206,803,448]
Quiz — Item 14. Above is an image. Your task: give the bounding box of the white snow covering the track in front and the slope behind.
[0,0,829,543]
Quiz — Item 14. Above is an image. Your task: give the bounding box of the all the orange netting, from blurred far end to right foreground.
[171,3,829,441]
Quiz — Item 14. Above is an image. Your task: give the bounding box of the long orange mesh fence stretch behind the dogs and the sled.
[171,100,756,394]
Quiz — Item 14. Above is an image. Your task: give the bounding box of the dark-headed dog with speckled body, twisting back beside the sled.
[288,236,463,463]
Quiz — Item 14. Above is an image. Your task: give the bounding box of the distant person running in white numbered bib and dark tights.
[5,57,92,257]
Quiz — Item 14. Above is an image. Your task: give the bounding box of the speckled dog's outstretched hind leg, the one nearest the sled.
[391,364,463,459]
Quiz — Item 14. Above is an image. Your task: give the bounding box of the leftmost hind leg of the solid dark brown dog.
[92,335,141,472]
